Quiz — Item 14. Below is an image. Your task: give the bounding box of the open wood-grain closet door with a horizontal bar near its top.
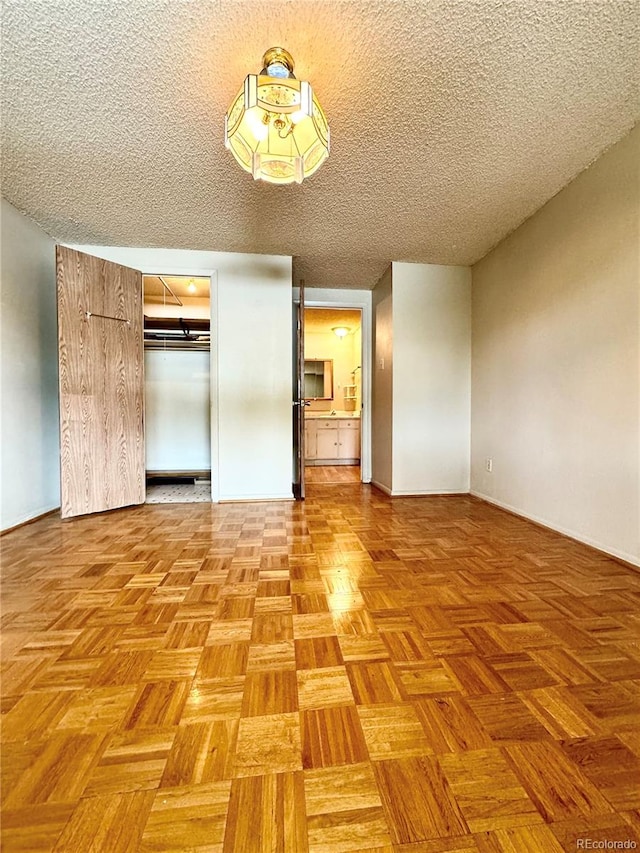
[56,246,145,518]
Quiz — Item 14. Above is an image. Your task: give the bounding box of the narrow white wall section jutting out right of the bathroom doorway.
[391,262,471,495]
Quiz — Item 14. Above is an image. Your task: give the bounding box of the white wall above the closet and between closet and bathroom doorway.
[74,246,293,500]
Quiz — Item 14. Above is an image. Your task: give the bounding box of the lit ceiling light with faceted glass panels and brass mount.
[224,47,329,184]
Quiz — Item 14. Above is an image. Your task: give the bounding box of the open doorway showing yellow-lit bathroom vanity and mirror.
[304,307,363,485]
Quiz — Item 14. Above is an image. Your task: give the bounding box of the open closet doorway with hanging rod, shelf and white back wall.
[142,274,212,503]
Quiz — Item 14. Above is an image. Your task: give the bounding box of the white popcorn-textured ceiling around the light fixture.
[2,0,640,288]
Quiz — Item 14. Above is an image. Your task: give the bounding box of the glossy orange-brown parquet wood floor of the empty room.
[1,484,640,853]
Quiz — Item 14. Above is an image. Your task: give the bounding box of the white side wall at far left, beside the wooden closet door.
[0,199,60,530]
